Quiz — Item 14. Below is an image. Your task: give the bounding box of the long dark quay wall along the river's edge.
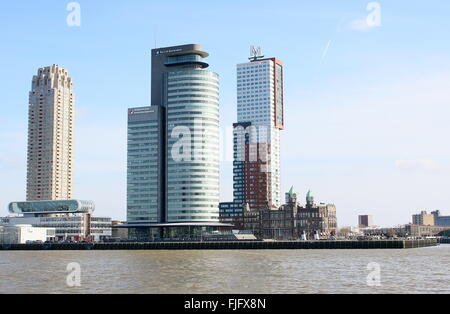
[0,239,438,251]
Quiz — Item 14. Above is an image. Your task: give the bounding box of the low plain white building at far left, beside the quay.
[0,225,56,244]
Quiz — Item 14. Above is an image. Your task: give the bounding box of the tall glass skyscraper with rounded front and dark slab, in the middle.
[128,45,219,239]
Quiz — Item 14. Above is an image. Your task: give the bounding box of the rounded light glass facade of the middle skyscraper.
[166,70,219,222]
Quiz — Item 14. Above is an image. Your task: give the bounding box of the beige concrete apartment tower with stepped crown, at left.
[27,65,75,201]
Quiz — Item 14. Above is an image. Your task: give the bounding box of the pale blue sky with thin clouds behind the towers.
[0,0,450,226]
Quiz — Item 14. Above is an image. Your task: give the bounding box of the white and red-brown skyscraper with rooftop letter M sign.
[234,56,284,210]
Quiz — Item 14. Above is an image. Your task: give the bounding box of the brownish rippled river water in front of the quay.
[0,245,450,294]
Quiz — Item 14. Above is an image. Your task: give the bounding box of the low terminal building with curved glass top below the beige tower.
[0,200,112,241]
